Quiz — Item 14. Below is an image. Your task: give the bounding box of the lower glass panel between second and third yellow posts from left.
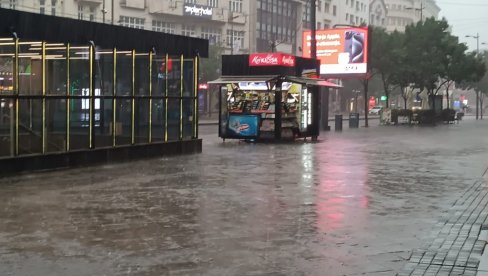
[46,99,66,152]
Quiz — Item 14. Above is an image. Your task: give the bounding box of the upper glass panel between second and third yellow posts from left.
[46,46,66,95]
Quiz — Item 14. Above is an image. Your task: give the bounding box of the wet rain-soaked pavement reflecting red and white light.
[0,120,488,275]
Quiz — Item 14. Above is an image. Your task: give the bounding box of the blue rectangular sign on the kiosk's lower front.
[227,114,260,138]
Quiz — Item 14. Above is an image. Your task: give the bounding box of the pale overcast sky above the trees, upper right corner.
[436,0,488,51]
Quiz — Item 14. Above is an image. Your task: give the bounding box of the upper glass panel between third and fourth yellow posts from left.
[69,47,90,96]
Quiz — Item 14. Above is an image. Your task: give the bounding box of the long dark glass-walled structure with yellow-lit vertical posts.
[0,9,208,173]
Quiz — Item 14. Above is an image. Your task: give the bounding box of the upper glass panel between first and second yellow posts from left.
[19,42,42,95]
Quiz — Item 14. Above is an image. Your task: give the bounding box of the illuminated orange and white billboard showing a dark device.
[302,27,368,75]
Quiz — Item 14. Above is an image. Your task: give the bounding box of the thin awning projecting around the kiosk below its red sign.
[208,75,342,88]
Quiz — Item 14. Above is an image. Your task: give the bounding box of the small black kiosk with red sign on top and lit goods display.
[210,53,337,141]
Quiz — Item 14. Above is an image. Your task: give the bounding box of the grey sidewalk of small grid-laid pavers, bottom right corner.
[398,171,488,276]
